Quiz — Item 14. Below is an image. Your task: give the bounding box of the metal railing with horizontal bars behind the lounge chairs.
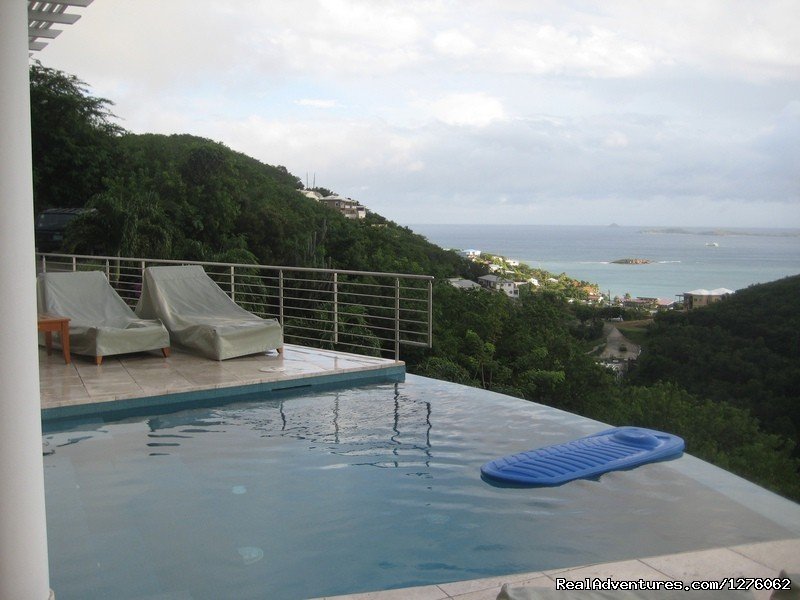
[36,253,433,360]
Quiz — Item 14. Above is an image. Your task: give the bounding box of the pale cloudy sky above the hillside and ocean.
[36,0,800,227]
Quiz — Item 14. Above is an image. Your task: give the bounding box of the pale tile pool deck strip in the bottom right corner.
[324,538,800,600]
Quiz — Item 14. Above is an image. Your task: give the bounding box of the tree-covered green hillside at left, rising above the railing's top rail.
[31,64,477,277]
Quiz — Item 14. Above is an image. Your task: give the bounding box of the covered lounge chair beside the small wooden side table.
[36,271,169,365]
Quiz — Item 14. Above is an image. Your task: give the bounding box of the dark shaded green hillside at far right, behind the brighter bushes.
[631,275,800,440]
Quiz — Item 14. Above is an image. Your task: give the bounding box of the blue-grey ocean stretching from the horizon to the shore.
[408,225,800,300]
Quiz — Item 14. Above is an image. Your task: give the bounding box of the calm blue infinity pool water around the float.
[44,376,800,600]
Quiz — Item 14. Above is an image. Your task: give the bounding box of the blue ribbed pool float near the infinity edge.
[481,427,684,486]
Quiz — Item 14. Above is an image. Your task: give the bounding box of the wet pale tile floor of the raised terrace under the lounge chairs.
[39,345,403,408]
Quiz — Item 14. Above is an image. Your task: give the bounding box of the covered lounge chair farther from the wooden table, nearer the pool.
[136,265,283,360]
